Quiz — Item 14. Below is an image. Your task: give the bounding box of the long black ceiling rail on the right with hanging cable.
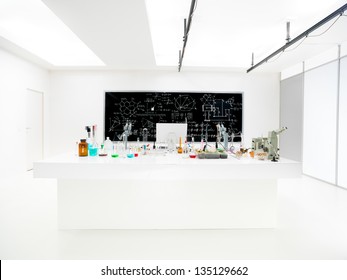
[247,3,347,73]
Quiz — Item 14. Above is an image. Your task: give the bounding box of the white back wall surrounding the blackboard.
[49,70,280,154]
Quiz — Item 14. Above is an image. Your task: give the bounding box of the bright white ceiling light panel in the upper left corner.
[0,0,105,66]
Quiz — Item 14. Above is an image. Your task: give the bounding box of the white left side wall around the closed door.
[0,48,49,176]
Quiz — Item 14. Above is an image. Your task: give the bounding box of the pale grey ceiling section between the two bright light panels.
[43,0,155,69]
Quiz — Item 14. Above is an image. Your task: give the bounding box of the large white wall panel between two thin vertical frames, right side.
[303,61,338,184]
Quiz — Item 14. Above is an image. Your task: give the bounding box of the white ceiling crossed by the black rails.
[0,0,347,72]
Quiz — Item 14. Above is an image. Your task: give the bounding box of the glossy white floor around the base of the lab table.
[0,172,347,260]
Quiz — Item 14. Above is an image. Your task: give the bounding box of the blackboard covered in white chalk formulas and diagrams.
[104,91,243,142]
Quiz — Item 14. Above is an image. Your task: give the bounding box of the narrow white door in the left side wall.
[26,89,43,170]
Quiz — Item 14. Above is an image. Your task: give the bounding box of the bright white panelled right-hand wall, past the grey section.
[282,42,347,188]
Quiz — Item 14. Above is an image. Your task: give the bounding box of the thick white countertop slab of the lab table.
[34,153,301,180]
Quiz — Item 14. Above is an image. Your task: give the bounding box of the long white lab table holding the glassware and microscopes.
[34,154,301,229]
